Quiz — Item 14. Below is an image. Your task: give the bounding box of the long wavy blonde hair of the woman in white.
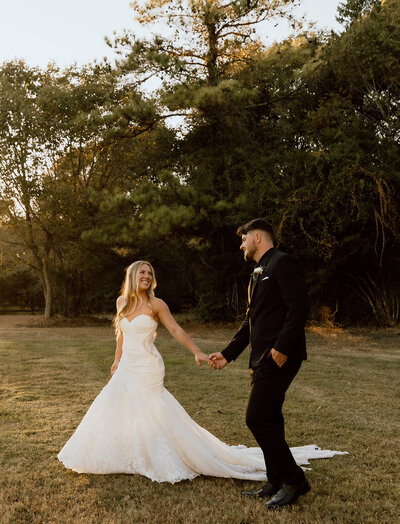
[113,260,157,335]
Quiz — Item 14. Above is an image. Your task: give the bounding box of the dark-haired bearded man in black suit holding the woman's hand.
[210,218,310,509]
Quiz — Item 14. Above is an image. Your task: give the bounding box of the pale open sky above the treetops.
[0,0,340,67]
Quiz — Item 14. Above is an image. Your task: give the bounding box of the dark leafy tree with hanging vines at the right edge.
[278,2,400,325]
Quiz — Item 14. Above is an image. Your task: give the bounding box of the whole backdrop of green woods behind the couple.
[0,0,400,325]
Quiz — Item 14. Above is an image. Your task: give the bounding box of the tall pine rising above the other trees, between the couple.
[96,0,306,318]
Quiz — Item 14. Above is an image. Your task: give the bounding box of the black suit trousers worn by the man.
[246,357,305,487]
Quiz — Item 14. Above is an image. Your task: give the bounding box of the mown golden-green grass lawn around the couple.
[0,316,400,524]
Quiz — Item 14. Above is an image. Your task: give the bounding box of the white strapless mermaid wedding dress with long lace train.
[58,314,346,483]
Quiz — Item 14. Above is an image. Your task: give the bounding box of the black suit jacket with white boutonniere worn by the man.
[222,247,308,369]
